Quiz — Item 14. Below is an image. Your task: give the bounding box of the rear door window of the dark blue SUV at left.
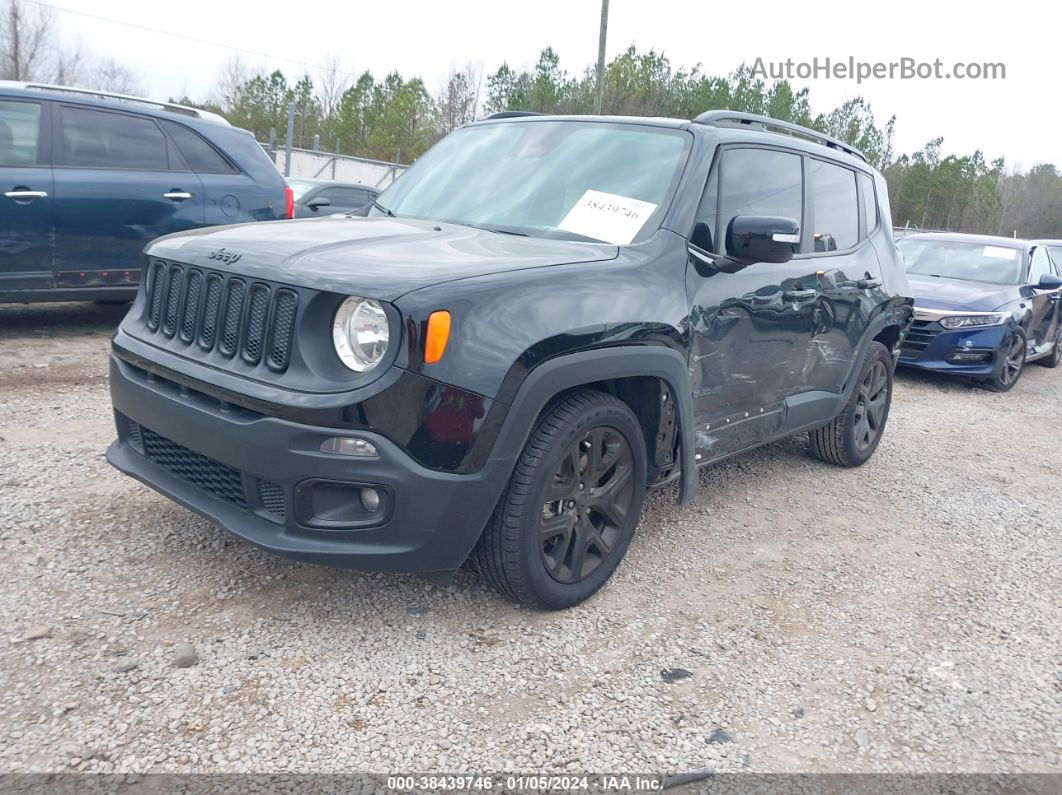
[63,107,170,171]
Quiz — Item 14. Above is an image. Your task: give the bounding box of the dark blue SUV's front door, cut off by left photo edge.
[0,97,53,292]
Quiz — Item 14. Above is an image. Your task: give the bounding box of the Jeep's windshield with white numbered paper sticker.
[374,121,690,244]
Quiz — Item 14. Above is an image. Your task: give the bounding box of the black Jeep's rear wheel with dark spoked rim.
[808,342,892,467]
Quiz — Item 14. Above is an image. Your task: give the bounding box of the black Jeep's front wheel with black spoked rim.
[474,390,647,610]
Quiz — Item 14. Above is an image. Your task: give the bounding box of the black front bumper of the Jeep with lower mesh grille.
[107,356,513,573]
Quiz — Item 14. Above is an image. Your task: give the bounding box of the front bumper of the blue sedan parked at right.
[898,321,1012,378]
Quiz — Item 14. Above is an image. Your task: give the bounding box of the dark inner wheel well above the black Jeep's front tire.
[539,376,681,482]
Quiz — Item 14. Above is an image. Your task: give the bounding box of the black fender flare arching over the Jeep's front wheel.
[491,345,697,505]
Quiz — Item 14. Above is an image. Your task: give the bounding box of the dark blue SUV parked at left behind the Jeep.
[0,82,292,301]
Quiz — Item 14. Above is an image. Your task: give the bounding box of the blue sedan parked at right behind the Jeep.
[897,234,1062,392]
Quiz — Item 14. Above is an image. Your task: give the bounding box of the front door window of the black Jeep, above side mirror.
[719,149,804,253]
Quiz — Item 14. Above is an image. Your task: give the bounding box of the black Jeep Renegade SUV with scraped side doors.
[107,111,911,608]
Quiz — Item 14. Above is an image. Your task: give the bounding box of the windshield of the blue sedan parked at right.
[896,239,1023,284]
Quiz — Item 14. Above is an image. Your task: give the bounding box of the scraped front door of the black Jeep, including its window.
[687,146,819,461]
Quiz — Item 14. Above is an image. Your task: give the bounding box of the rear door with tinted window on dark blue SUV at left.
[52,104,204,287]
